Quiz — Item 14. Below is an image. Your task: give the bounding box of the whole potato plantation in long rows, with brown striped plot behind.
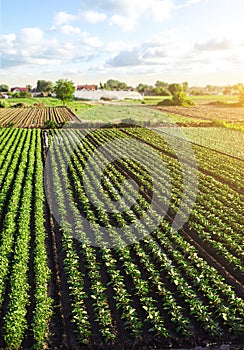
[0,108,244,349]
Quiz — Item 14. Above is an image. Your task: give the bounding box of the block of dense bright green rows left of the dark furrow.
[0,129,51,349]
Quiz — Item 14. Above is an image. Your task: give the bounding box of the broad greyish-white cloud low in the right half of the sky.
[105,31,244,76]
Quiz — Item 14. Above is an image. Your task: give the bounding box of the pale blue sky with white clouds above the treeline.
[0,0,244,87]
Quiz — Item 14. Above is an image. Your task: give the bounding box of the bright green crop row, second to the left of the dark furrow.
[3,133,36,349]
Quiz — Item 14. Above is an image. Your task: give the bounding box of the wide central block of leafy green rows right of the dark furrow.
[44,126,243,343]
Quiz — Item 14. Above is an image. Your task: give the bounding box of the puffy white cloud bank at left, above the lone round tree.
[0,25,103,68]
